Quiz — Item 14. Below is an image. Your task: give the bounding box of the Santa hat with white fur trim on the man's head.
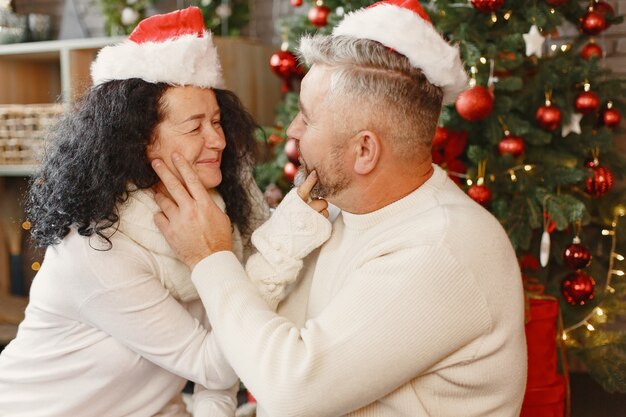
[332,0,468,104]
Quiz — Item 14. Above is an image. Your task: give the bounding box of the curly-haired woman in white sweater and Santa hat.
[0,8,267,417]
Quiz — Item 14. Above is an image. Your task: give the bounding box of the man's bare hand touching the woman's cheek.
[152,153,232,269]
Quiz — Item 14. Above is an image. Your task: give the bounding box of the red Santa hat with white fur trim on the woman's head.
[91,7,224,88]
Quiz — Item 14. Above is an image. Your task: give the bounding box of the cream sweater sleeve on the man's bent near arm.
[192,246,491,417]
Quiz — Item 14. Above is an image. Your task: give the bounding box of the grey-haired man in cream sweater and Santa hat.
[154,1,526,417]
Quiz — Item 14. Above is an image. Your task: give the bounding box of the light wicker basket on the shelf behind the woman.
[0,104,63,165]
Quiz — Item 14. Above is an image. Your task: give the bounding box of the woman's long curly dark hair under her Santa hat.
[26,78,258,246]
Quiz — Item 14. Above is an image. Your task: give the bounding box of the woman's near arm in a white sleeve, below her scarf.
[78,237,237,390]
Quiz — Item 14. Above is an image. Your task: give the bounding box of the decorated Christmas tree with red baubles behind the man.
[256,0,626,392]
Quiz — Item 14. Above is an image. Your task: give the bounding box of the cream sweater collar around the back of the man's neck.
[341,164,449,230]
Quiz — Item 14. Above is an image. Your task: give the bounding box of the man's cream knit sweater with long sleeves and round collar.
[192,167,526,417]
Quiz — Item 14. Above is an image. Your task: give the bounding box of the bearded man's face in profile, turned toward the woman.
[287,65,350,198]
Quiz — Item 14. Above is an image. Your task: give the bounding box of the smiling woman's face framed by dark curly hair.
[147,86,226,190]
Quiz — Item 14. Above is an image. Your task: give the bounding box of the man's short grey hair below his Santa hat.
[299,35,443,157]
